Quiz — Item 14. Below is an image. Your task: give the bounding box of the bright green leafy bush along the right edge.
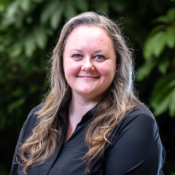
[137,8,175,116]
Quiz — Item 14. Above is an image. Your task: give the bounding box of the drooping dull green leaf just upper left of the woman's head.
[50,2,65,29]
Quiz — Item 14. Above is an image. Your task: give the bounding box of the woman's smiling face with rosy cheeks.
[63,25,116,99]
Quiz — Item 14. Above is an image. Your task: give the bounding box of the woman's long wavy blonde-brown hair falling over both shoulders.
[20,12,140,174]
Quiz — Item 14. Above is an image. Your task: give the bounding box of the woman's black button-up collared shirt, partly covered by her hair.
[10,102,165,175]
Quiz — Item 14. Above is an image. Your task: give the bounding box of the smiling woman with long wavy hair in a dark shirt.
[11,12,165,175]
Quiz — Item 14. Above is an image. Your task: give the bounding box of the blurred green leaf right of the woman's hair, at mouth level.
[136,60,156,81]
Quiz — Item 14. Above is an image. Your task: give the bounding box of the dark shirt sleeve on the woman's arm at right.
[105,114,163,175]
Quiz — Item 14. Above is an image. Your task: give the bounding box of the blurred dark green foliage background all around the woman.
[0,0,175,175]
